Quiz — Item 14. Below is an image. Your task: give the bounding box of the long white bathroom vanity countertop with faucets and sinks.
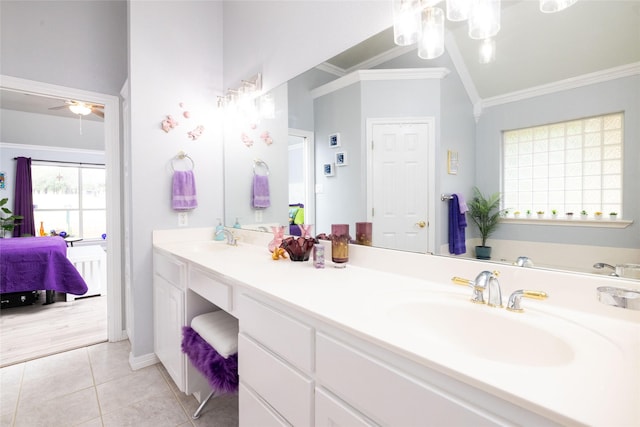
[154,231,640,426]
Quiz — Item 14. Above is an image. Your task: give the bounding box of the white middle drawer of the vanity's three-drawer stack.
[238,333,313,426]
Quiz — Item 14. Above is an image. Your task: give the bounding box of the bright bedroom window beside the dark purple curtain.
[31,160,107,240]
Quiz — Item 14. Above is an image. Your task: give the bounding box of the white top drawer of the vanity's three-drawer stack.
[238,295,314,373]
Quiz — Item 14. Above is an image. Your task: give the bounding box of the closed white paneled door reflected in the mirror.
[371,123,432,253]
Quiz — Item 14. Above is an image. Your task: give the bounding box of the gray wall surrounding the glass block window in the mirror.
[476,76,640,248]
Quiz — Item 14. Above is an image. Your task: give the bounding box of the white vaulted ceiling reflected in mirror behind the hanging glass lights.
[327,0,640,99]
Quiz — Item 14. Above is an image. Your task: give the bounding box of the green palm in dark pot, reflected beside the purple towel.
[467,187,504,259]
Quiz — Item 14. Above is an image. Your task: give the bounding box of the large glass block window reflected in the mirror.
[502,113,624,218]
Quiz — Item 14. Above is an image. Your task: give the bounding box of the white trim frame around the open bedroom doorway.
[0,75,126,352]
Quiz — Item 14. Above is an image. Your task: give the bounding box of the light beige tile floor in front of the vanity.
[0,341,238,427]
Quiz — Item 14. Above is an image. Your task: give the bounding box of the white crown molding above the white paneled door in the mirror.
[311,68,451,99]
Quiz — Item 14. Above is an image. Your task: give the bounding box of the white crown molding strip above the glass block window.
[482,62,640,109]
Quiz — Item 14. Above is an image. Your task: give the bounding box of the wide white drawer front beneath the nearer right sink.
[316,333,500,426]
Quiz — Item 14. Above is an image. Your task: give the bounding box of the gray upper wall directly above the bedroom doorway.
[0,0,127,95]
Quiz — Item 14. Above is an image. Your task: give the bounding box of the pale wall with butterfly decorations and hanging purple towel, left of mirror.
[124,1,223,357]
